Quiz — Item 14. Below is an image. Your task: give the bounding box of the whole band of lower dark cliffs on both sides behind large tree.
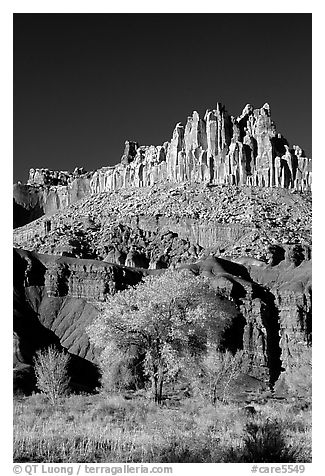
[14,250,311,390]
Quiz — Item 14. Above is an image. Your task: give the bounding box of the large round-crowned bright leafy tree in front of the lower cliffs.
[88,270,237,403]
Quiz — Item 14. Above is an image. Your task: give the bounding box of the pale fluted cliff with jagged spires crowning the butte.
[14,99,312,230]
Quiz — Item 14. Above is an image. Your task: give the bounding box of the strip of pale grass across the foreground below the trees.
[14,394,311,463]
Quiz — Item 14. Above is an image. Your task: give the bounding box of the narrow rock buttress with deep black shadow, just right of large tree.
[182,257,281,387]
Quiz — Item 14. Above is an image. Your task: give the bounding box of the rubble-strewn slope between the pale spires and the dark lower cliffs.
[14,184,311,268]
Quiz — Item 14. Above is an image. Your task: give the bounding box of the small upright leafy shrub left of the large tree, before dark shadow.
[34,346,70,404]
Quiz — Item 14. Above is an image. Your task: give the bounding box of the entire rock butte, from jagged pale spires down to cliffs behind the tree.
[14,97,311,398]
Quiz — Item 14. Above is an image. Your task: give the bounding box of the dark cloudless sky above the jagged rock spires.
[14,13,312,182]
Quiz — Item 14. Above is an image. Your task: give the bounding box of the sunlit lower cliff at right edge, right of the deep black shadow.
[250,256,312,393]
